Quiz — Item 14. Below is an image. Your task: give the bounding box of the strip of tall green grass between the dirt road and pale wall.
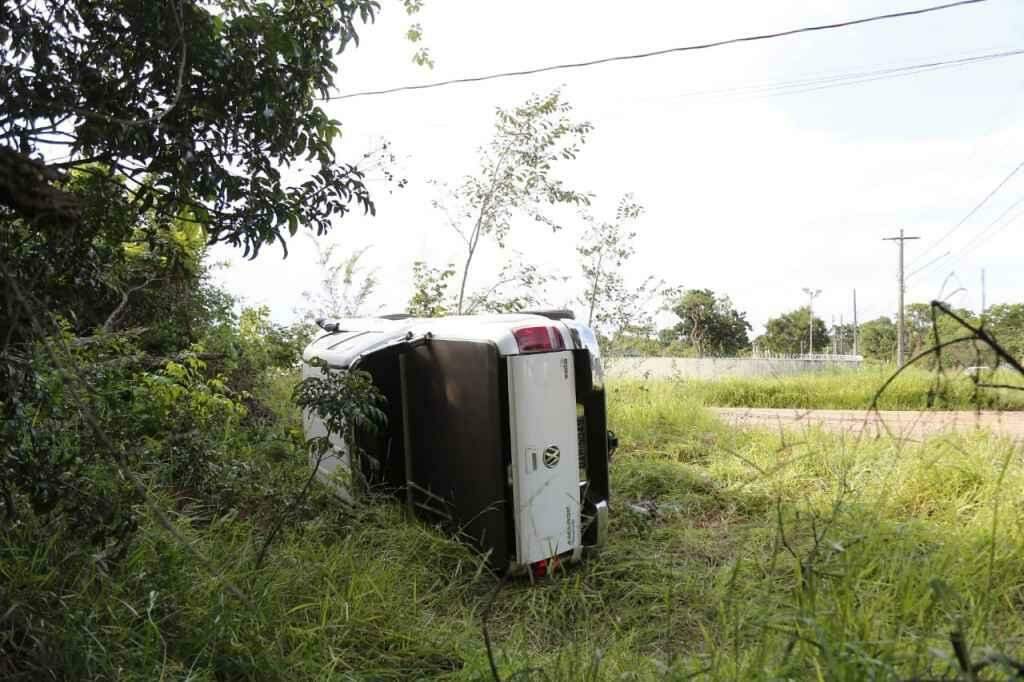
[663,366,1024,410]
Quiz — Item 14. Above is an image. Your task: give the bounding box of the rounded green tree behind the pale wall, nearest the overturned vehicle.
[672,289,752,355]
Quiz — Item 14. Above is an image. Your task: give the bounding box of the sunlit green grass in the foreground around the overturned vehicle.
[8,374,1024,681]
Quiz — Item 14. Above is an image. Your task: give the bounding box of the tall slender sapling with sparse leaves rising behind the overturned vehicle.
[434,90,592,313]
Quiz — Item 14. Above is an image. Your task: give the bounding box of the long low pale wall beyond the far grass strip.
[604,353,863,379]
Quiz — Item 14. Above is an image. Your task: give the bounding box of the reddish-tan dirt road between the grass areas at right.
[712,408,1024,439]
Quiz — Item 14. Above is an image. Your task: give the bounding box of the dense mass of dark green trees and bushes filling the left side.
[0,0,413,577]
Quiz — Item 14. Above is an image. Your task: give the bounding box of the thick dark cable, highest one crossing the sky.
[326,0,988,100]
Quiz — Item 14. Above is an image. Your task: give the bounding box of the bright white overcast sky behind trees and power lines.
[213,0,1024,334]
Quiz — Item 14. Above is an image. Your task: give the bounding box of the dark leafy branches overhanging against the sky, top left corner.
[0,0,385,255]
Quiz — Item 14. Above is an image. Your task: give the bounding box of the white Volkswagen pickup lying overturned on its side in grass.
[303,310,616,576]
